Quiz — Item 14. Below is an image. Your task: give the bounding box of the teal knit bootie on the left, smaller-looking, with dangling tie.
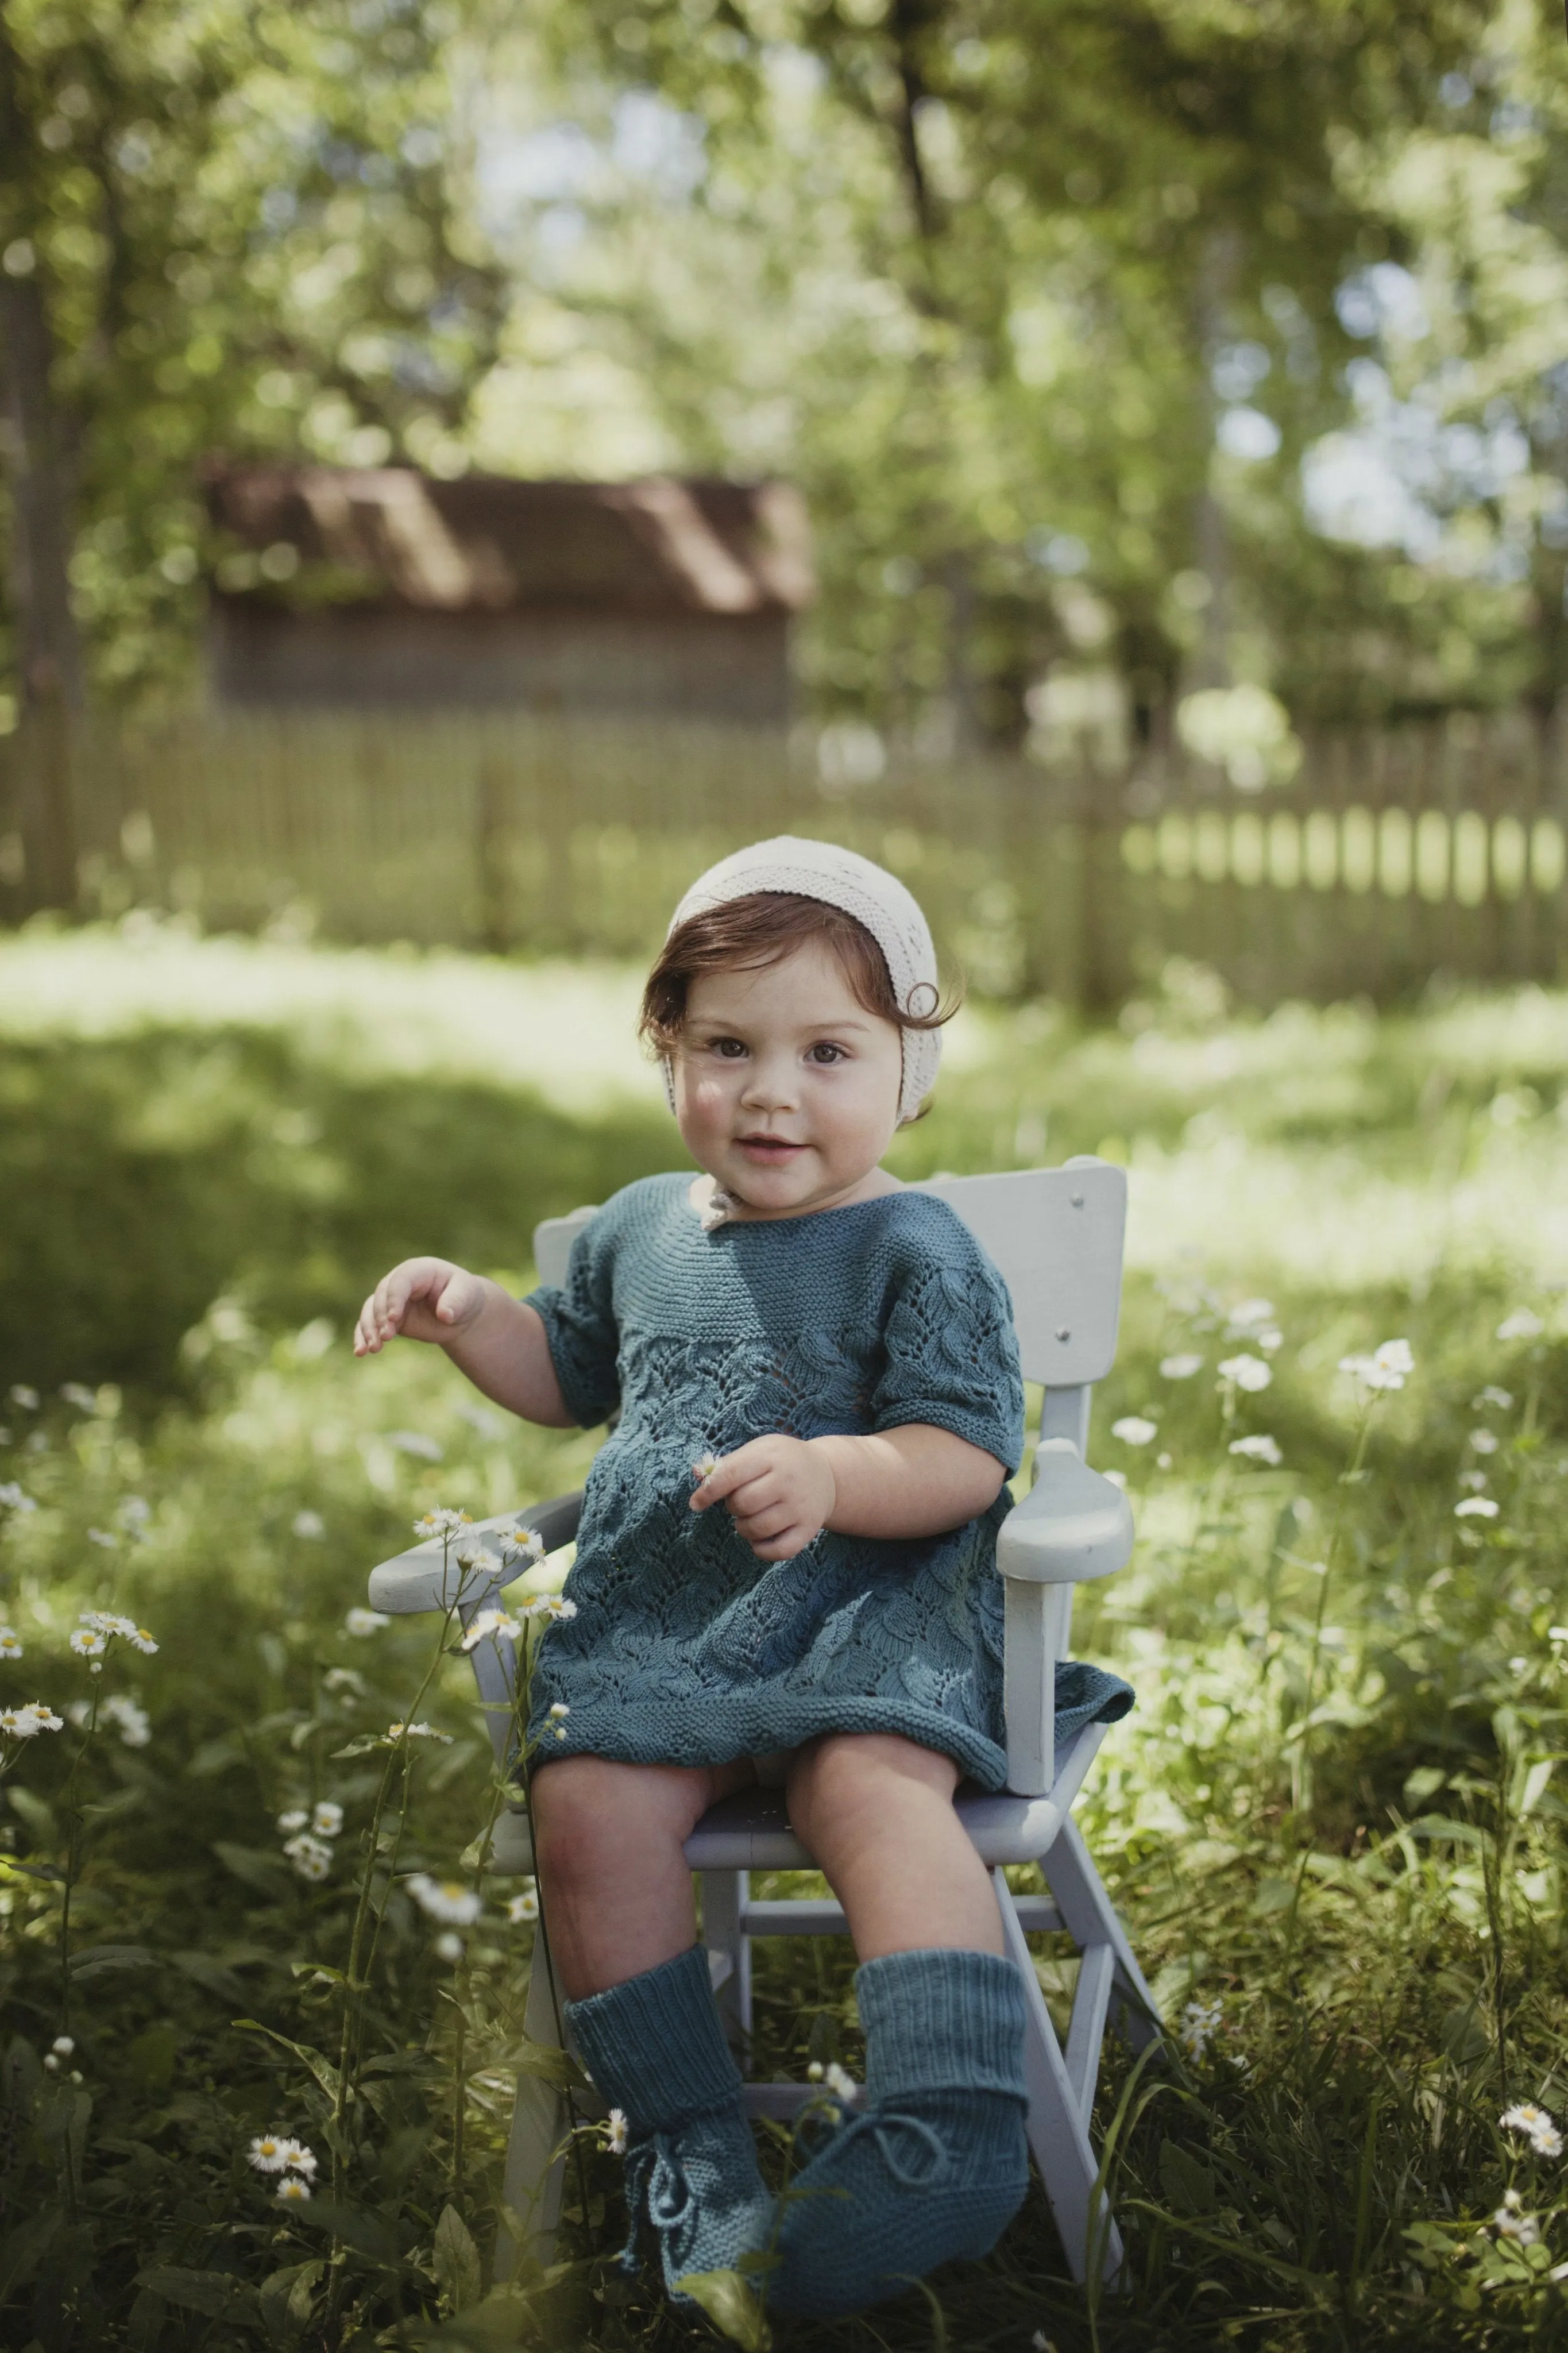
[566,1943,774,2304]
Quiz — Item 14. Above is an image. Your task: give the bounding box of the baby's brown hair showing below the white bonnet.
[637,889,959,1054]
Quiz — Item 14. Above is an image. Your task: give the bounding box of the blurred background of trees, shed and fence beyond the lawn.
[0,0,1568,1009]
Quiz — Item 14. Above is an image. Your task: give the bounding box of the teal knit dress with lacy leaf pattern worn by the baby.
[531,1176,1133,1788]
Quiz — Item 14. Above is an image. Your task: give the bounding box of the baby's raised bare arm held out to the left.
[355,1259,574,1430]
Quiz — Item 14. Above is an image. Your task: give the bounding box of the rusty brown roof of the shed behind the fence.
[207,466,816,614]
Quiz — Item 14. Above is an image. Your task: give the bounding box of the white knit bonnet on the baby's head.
[665,833,943,1123]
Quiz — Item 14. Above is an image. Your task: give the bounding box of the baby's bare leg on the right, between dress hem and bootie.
[787,1732,1006,1960]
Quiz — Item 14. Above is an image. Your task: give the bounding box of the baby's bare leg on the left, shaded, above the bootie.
[534,1756,752,2003]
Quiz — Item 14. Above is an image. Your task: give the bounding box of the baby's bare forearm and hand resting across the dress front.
[691,1421,1006,1560]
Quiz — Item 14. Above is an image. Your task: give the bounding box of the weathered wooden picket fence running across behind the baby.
[0,713,1568,1007]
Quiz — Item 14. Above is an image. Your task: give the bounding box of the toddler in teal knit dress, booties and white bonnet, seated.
[355,838,1131,2318]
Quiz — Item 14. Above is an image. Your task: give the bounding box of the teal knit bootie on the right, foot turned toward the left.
[766,1951,1030,2320]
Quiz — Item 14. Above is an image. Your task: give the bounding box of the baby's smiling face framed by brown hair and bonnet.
[675,939,903,1217]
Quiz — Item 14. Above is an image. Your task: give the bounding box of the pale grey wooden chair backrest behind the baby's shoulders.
[534,1158,1126,1388]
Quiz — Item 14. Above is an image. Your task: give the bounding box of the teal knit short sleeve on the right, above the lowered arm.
[872,1219,1022,1478]
